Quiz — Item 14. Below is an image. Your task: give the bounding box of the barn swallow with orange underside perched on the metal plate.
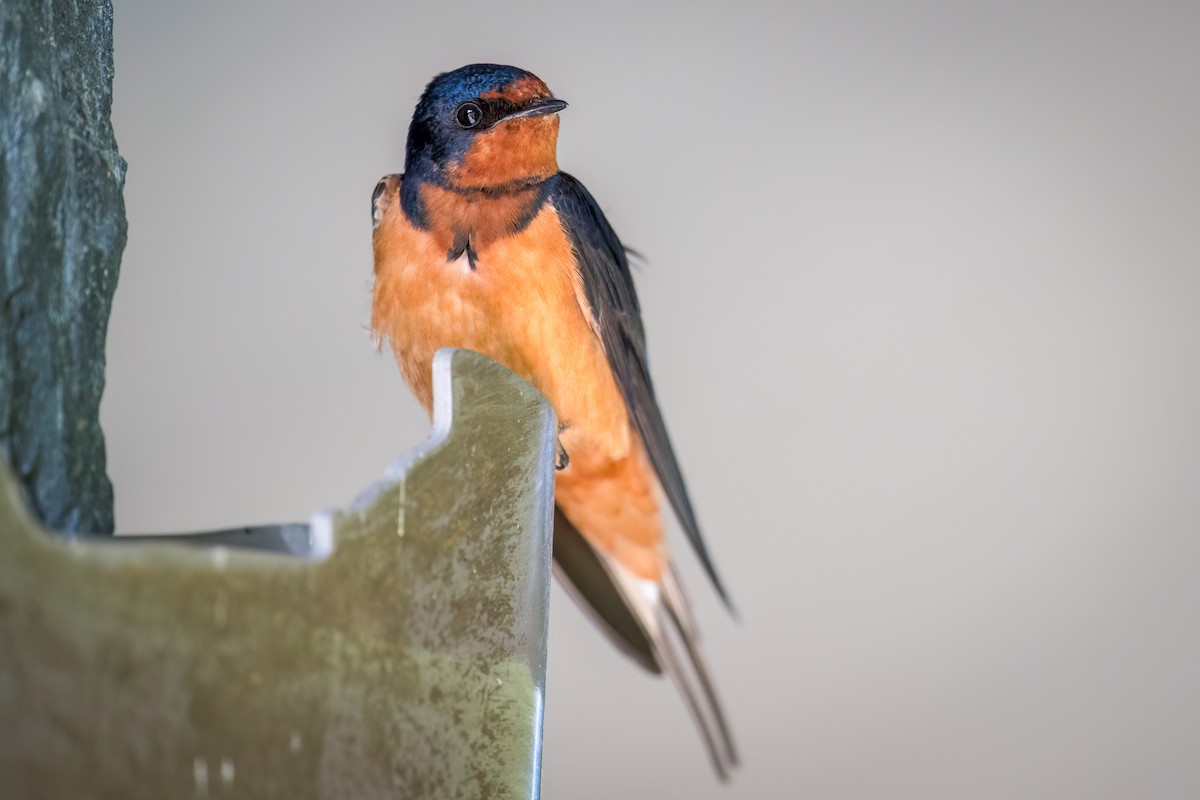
[371,64,738,780]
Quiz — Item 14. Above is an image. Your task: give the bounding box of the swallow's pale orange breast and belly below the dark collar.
[372,178,665,578]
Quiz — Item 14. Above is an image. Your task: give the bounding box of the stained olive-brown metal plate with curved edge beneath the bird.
[0,350,554,799]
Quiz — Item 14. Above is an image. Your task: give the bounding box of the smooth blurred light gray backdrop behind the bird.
[103,0,1200,800]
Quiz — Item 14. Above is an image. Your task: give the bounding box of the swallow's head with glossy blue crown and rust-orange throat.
[404,64,566,191]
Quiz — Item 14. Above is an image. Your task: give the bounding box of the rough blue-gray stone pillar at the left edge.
[0,0,126,534]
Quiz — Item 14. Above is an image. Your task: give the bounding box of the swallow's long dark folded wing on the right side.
[550,173,730,604]
